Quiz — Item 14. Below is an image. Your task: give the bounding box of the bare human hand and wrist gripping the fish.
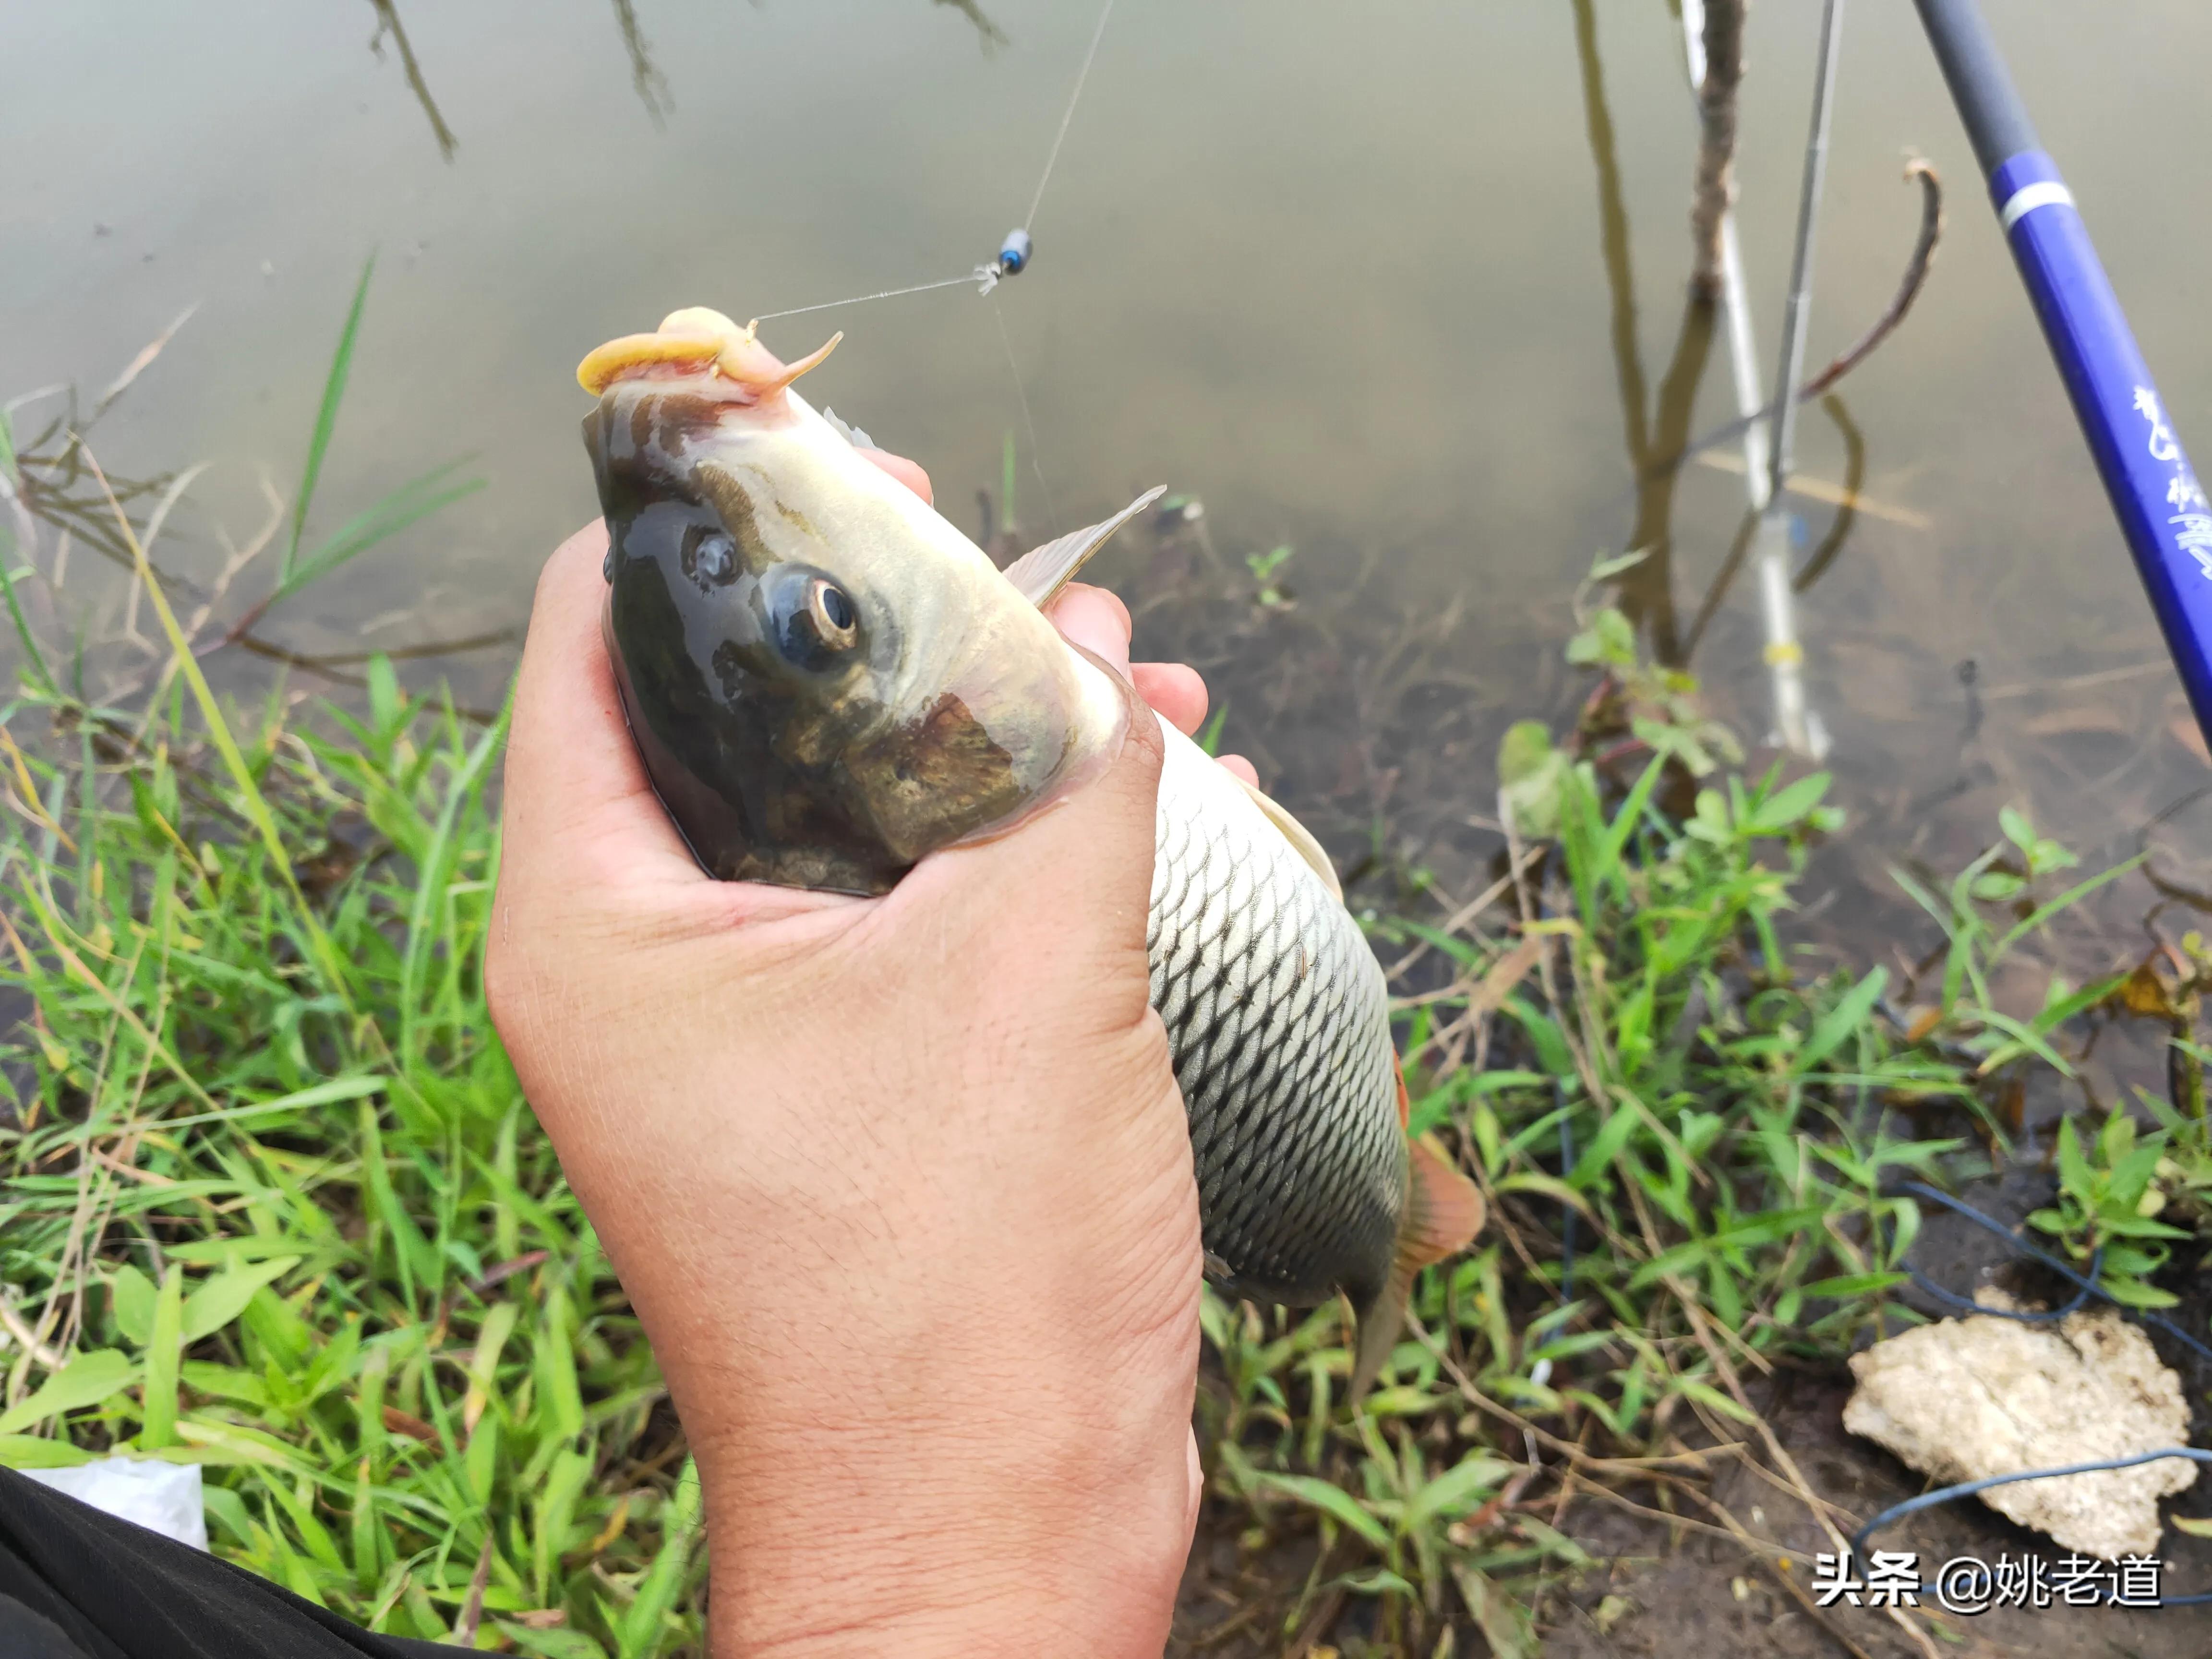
[484,456,1205,1659]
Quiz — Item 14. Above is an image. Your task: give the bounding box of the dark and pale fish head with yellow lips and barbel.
[579,312,1124,894]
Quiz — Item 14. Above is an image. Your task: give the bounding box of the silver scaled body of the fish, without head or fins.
[1146,728,1407,1307]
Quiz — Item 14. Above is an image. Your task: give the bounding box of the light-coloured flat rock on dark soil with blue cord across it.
[1842,1310,2197,1562]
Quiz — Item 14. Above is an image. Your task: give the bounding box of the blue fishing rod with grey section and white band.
[1913,0,2212,741]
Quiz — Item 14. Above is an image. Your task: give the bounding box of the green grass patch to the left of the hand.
[0,668,697,1655]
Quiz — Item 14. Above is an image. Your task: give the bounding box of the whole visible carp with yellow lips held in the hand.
[577,308,1484,1398]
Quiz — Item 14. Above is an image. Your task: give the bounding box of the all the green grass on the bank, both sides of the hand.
[0,305,2212,1659]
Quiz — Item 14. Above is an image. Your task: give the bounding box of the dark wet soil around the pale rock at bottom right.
[1168,1161,2212,1659]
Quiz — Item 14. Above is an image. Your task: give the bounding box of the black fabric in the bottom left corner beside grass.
[0,1469,454,1659]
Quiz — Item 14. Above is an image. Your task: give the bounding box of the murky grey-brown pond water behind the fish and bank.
[13,0,2212,1026]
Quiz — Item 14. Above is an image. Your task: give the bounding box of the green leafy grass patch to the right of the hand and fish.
[1201,592,2212,1659]
